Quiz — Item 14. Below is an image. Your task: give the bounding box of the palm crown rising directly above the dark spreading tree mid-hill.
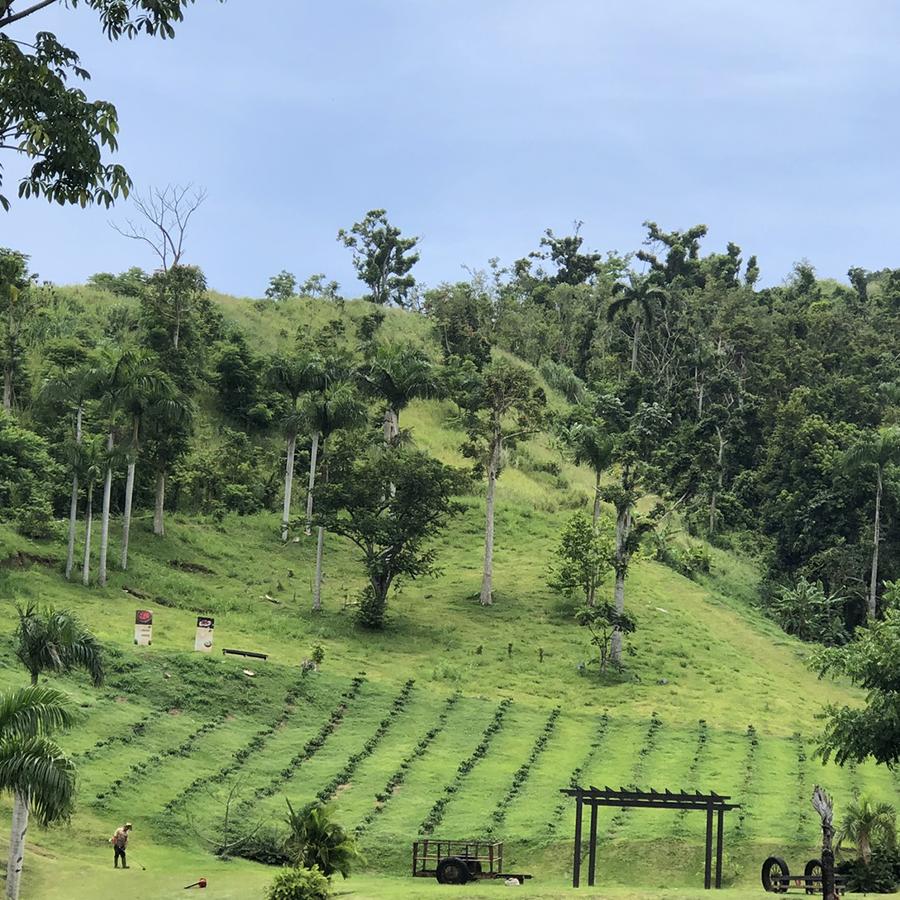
[363,344,439,443]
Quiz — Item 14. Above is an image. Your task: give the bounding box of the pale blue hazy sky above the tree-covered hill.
[0,0,900,296]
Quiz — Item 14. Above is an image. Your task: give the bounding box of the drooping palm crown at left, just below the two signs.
[15,603,104,687]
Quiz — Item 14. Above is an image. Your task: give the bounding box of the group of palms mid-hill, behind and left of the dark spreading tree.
[268,344,439,610]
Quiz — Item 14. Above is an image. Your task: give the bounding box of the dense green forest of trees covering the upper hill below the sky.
[0,214,900,643]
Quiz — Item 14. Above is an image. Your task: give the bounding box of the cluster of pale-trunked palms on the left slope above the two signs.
[41,347,192,586]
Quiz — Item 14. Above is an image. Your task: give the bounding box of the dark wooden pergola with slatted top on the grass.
[560,785,740,890]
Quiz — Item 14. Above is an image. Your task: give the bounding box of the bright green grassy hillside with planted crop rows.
[0,297,898,898]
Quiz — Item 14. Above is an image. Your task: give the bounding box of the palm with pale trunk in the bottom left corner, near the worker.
[0,686,75,900]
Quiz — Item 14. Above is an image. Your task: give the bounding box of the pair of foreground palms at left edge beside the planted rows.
[0,604,104,900]
